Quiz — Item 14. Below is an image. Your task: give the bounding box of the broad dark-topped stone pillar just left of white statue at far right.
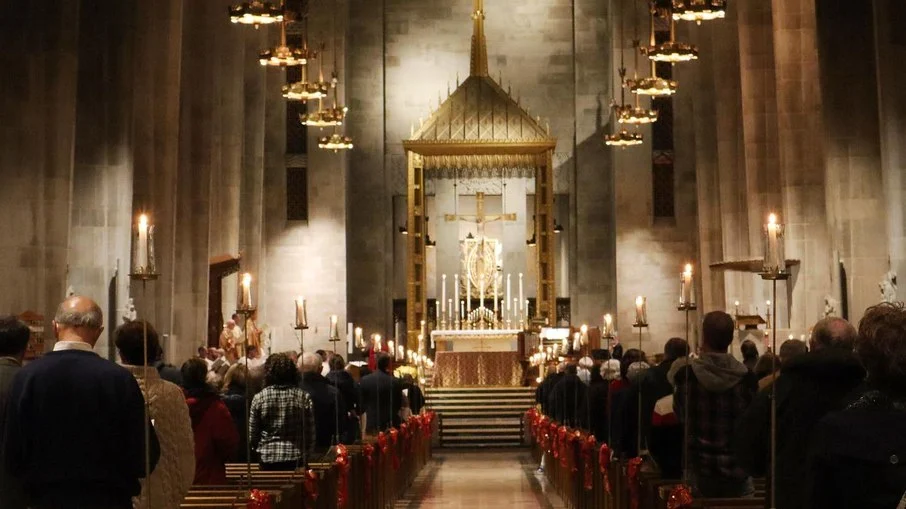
[816,0,889,322]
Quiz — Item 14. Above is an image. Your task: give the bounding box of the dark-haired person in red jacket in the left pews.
[181,359,239,485]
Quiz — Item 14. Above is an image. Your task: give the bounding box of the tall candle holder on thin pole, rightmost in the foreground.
[758,213,790,509]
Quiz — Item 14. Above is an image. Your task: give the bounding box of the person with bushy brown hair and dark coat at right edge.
[806,303,906,509]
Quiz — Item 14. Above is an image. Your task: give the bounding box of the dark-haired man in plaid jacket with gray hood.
[667,311,758,498]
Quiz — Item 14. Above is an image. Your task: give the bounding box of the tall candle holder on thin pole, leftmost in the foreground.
[129,214,160,507]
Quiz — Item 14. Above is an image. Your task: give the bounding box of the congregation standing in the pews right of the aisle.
[536,303,906,509]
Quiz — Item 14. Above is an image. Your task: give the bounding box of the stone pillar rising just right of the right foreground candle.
[771,0,832,331]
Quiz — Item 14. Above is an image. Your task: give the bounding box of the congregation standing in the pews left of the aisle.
[0,296,424,509]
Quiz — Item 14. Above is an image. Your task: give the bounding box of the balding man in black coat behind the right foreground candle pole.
[734,318,865,509]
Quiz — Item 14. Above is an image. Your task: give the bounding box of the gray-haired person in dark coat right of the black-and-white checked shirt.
[299,353,348,454]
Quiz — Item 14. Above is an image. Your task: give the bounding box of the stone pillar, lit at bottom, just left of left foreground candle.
[68,0,137,360]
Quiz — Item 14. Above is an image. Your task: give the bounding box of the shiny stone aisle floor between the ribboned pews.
[396,449,565,509]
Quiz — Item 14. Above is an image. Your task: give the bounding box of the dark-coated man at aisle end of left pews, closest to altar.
[359,352,403,433]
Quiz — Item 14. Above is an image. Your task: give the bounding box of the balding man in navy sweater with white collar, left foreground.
[4,296,160,509]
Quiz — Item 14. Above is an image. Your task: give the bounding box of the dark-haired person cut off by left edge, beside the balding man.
[0,315,31,509]
